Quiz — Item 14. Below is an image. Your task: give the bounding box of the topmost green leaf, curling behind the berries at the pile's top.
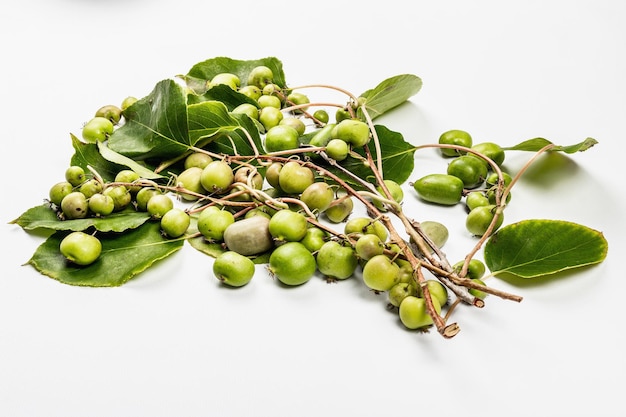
[183,57,287,88]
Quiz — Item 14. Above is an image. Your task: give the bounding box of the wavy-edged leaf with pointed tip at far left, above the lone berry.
[11,204,150,232]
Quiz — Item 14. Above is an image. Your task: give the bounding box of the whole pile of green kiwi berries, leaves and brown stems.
[13,57,608,337]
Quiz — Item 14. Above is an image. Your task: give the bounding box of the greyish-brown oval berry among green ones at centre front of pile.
[223,216,274,256]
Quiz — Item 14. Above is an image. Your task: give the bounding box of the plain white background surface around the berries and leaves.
[0,0,626,417]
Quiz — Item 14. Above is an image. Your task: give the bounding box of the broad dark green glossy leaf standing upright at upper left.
[108,79,191,160]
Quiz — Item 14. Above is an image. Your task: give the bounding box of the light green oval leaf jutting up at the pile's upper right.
[358,74,422,120]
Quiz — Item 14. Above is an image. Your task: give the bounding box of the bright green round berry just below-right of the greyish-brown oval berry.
[268,242,317,286]
